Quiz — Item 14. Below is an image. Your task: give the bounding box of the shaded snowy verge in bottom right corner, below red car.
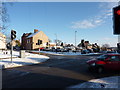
[68,76,120,88]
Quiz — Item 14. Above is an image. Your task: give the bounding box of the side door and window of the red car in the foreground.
[105,55,119,70]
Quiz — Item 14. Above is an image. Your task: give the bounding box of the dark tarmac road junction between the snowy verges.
[2,55,120,89]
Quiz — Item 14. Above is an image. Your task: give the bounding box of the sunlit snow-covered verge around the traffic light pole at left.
[0,51,49,69]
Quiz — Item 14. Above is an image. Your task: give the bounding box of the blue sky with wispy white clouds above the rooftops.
[6,2,118,46]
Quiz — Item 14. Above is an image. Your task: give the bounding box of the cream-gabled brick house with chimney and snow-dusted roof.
[21,29,49,50]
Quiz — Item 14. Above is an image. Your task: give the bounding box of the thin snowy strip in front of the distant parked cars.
[31,51,100,55]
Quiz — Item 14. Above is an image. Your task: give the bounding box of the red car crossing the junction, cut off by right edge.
[87,54,120,73]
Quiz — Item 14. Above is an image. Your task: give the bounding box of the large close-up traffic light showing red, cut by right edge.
[113,5,120,35]
